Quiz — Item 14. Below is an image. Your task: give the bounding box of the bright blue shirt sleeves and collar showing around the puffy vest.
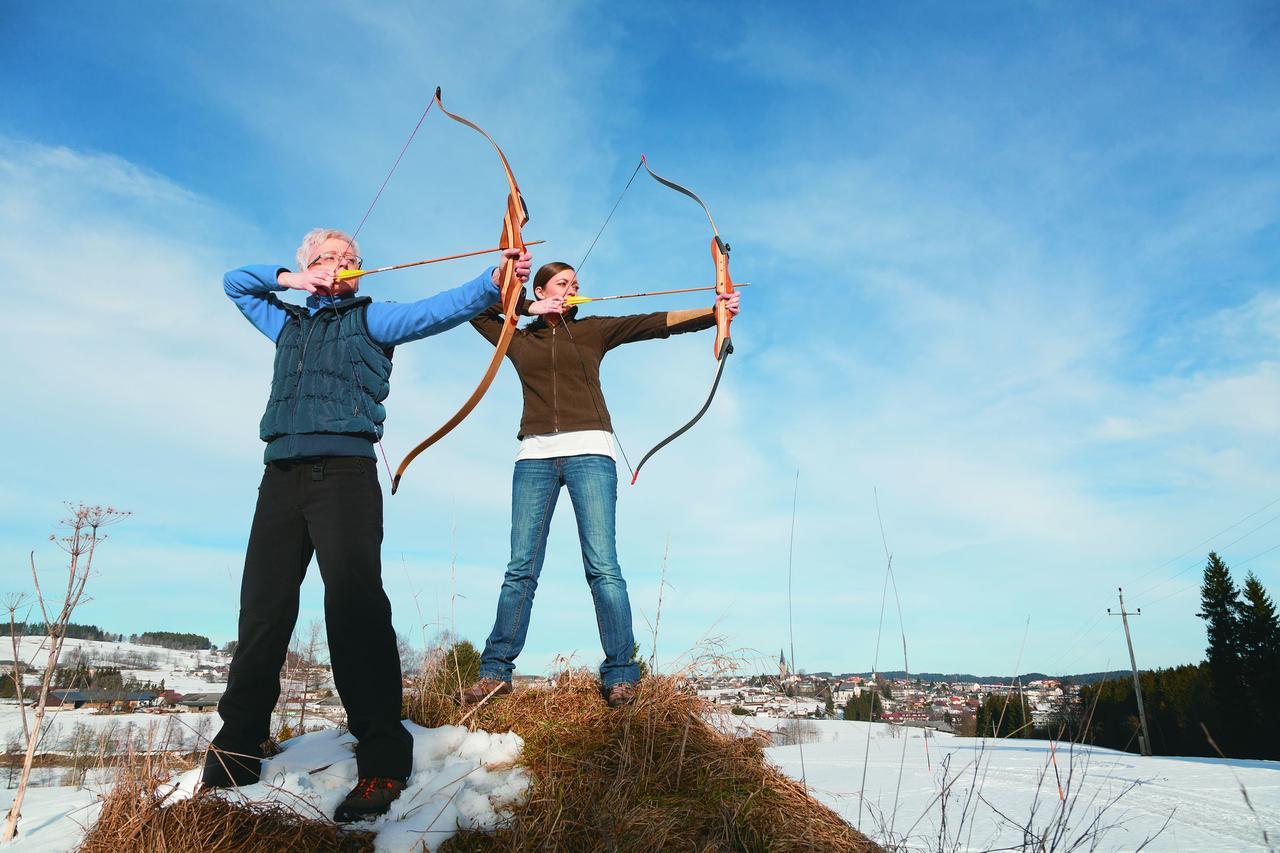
[223,264,498,347]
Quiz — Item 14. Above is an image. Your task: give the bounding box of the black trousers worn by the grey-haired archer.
[214,456,413,777]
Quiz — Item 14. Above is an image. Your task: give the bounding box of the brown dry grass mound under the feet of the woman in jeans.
[410,671,879,850]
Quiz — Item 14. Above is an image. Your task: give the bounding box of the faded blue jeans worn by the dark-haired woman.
[480,455,640,689]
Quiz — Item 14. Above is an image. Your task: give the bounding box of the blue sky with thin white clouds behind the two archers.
[0,3,1280,672]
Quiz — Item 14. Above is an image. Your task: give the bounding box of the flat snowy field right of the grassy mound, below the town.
[750,717,1280,852]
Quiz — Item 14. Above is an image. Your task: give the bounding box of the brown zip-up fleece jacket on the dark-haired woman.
[471,305,716,438]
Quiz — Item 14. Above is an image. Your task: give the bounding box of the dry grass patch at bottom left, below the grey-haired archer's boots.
[78,757,374,853]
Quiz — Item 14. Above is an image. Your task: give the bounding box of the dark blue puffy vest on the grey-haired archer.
[259,296,392,462]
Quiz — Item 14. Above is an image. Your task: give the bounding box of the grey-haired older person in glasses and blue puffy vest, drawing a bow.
[204,228,530,821]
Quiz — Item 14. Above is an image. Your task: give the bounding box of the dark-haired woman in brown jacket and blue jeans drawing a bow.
[461,263,739,707]
